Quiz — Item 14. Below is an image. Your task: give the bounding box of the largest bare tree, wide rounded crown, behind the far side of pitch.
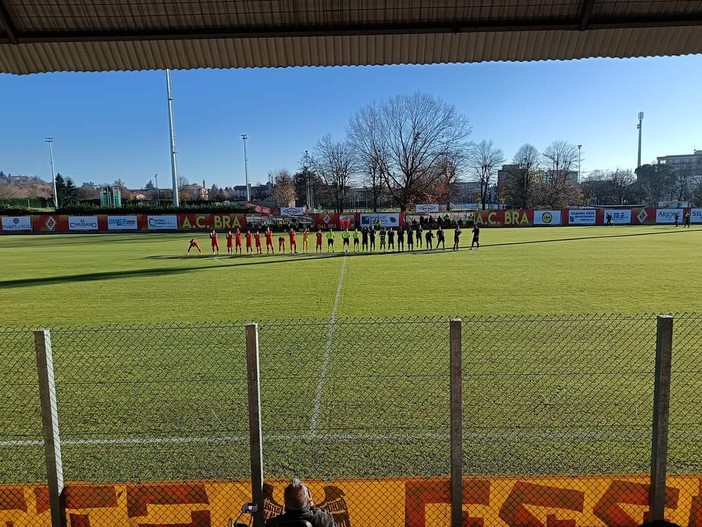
[349,93,471,211]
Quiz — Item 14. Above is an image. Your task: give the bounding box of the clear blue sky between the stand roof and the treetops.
[0,55,702,187]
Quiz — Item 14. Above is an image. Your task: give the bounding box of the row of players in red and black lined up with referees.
[187,225,480,255]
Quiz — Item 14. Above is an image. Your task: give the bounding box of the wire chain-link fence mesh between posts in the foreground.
[0,315,702,527]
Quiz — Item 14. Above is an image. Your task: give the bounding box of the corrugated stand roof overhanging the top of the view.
[0,0,702,73]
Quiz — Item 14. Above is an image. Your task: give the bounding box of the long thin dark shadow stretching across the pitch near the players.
[0,228,700,289]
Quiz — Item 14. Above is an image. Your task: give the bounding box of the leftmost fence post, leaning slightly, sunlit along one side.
[34,329,66,527]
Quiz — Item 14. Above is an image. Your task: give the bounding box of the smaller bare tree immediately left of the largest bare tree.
[312,135,356,212]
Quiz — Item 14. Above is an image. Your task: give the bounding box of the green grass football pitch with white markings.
[0,226,702,482]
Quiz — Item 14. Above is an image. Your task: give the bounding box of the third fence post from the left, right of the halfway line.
[450,318,463,527]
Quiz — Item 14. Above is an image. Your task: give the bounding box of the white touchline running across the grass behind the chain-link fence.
[0,430,702,448]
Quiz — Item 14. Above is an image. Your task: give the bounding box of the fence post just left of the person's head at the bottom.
[246,324,264,527]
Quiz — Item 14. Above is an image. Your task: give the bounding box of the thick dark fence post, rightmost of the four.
[649,315,673,520]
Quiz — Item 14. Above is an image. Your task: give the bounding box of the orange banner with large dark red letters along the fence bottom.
[0,474,702,527]
